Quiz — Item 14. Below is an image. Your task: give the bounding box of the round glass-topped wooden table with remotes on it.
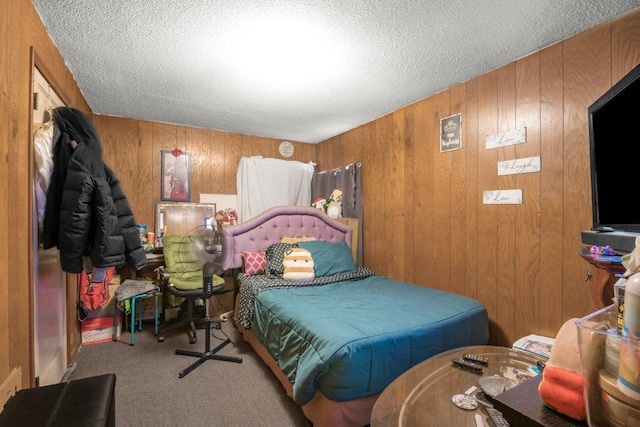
[371,346,538,427]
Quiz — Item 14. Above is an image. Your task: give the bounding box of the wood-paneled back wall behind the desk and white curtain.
[94,115,316,230]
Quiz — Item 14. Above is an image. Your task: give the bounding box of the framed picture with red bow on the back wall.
[160,148,191,202]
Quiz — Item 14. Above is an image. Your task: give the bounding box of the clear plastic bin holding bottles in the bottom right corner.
[576,304,640,427]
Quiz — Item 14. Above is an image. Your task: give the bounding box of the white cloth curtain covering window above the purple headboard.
[236,156,315,222]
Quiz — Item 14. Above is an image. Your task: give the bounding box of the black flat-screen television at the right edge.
[583,61,640,252]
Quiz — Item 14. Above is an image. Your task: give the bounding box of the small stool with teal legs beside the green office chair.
[113,279,160,345]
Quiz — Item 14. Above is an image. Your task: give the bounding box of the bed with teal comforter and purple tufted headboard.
[222,207,489,427]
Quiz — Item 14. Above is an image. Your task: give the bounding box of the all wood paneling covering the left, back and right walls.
[0,0,640,398]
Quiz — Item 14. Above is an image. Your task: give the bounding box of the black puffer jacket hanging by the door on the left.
[43,107,147,273]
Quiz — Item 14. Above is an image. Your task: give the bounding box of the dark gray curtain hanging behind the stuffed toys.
[311,162,364,267]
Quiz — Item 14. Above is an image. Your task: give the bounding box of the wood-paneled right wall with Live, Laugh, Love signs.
[317,10,640,345]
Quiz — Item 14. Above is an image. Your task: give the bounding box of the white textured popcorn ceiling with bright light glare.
[33,0,640,143]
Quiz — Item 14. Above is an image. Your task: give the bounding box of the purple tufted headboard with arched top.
[222,206,351,270]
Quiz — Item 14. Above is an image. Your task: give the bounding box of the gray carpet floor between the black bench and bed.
[66,321,311,427]
